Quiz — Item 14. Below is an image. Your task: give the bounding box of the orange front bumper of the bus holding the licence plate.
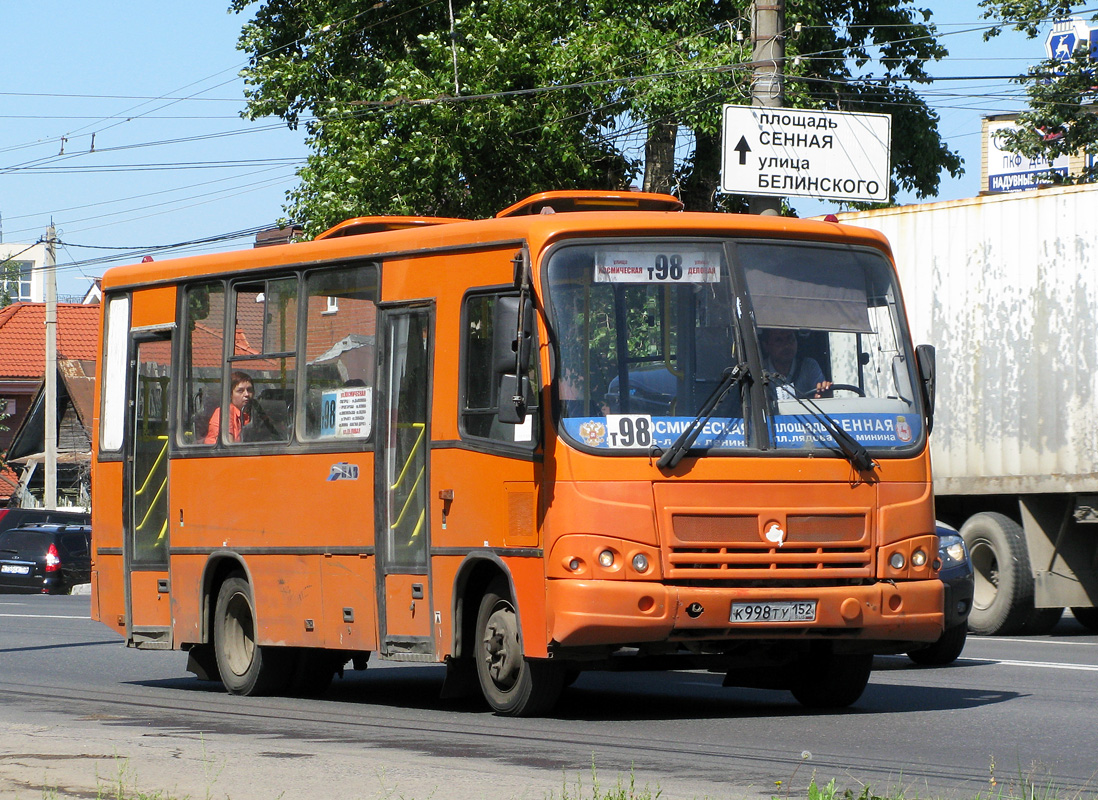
[547,579,944,646]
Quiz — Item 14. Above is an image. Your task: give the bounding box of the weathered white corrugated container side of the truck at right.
[840,185,1098,495]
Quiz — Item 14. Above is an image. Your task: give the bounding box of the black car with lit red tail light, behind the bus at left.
[0,522,91,595]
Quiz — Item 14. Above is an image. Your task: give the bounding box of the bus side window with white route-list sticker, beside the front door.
[299,263,378,441]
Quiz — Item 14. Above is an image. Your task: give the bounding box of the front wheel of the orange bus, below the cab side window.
[475,578,564,717]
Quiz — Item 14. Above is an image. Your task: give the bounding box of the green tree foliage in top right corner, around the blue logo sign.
[981,0,1098,183]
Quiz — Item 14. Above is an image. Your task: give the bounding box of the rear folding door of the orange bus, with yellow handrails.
[123,331,171,649]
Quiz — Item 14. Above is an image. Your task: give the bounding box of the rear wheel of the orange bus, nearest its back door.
[213,575,290,695]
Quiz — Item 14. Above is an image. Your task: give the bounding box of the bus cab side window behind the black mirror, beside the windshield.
[461,294,540,444]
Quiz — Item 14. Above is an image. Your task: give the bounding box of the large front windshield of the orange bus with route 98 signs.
[546,239,922,455]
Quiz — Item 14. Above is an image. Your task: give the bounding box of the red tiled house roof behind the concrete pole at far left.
[0,303,100,380]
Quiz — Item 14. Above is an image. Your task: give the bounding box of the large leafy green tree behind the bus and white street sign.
[231,0,961,228]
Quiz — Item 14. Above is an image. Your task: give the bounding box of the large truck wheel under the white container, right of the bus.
[961,511,1034,635]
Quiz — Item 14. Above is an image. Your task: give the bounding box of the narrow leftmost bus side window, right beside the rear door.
[177,282,225,444]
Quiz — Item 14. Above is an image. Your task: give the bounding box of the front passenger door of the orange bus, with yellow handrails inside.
[374,305,434,660]
